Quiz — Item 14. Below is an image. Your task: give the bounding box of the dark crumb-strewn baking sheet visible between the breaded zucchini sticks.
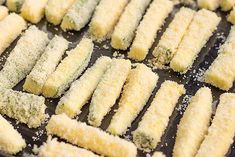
[0,3,235,157]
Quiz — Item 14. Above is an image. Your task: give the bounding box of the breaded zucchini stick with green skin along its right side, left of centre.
[42,38,94,98]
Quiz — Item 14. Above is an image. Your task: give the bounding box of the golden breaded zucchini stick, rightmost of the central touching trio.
[107,64,158,135]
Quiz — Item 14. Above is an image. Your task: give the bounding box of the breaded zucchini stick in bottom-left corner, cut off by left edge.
[0,115,26,154]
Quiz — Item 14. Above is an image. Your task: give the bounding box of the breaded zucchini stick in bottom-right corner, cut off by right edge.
[196,93,235,157]
